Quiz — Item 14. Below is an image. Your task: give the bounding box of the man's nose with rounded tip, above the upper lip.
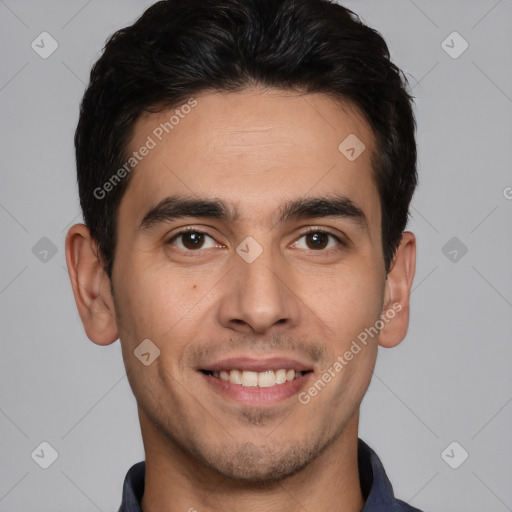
[219,241,301,334]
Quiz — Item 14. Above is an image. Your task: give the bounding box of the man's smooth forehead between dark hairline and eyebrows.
[119,88,380,227]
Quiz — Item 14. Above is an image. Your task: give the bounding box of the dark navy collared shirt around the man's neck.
[118,439,421,512]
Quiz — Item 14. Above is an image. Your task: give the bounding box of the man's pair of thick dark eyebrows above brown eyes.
[137,195,369,231]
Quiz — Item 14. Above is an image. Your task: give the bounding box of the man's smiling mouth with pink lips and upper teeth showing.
[199,358,313,406]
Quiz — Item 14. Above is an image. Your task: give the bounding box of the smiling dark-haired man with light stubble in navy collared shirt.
[66,0,417,512]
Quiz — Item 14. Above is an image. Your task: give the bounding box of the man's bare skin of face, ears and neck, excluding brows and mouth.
[66,88,416,512]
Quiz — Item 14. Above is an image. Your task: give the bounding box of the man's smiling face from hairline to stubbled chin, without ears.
[99,89,392,481]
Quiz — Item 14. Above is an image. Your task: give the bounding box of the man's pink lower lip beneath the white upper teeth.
[200,372,312,405]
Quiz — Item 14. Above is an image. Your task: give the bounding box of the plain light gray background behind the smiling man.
[0,0,512,512]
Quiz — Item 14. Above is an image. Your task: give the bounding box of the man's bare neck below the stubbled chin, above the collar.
[139,409,364,512]
